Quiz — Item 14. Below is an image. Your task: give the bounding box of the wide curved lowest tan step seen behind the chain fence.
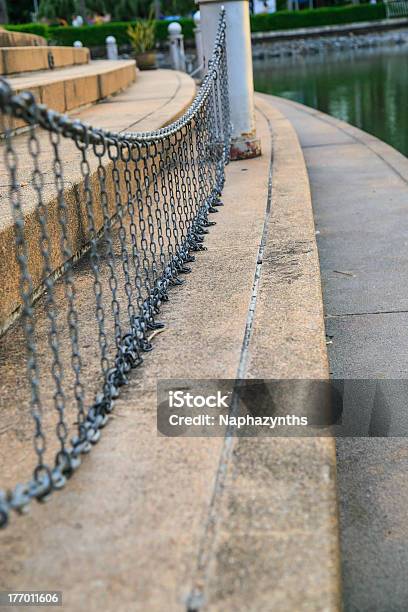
[0,69,195,330]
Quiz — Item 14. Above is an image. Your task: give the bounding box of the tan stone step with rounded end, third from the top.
[3,60,136,128]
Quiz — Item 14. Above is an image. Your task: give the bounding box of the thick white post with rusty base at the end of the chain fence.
[196,0,261,159]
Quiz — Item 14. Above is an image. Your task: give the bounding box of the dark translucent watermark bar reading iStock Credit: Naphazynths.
[157,379,408,437]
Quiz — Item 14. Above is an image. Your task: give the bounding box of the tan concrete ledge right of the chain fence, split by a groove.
[0,88,339,612]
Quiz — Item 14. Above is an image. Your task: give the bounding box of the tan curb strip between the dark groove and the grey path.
[204,96,341,612]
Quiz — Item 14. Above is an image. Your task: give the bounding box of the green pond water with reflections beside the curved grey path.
[254,47,408,156]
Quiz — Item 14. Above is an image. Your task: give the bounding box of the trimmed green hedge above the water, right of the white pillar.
[251,4,385,32]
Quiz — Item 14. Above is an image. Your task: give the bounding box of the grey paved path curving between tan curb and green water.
[262,98,408,612]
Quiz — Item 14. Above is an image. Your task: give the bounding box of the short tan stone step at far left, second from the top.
[0,46,90,75]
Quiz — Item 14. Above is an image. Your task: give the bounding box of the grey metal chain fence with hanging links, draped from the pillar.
[0,12,231,526]
